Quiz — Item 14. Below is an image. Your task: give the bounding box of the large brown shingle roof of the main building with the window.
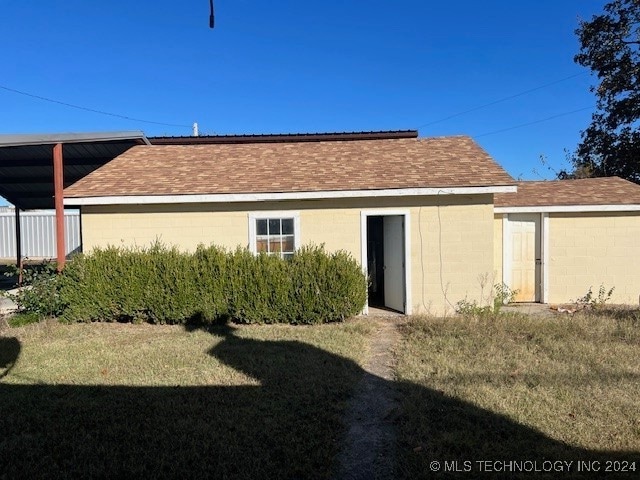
[65,136,515,197]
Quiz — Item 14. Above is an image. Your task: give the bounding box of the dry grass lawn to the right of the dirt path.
[397,313,640,478]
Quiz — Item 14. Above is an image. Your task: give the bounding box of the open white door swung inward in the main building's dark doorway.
[383,215,405,312]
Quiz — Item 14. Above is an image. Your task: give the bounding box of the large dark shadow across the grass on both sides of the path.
[0,326,640,479]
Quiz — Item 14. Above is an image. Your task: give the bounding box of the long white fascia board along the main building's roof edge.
[64,185,516,205]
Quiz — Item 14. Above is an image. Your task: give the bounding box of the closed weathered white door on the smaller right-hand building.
[509,213,542,302]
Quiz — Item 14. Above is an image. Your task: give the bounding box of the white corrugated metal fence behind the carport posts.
[0,211,80,259]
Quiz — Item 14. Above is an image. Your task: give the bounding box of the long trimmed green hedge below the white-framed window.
[60,244,366,324]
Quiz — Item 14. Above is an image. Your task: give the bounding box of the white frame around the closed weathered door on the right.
[502,212,549,303]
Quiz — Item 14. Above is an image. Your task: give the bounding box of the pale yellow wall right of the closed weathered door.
[549,212,640,304]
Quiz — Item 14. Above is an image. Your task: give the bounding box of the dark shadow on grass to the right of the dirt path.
[397,381,640,479]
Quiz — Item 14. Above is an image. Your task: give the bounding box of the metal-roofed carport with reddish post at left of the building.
[0,131,150,269]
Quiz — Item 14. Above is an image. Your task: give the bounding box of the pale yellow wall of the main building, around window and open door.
[82,195,495,314]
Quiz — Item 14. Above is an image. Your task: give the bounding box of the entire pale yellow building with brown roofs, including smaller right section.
[65,131,640,314]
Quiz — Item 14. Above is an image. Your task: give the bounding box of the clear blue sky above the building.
[0,0,606,204]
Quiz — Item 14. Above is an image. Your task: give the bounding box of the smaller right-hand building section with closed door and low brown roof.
[494,177,640,304]
